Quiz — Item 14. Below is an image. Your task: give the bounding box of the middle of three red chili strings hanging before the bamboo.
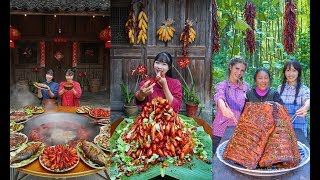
[244,1,256,55]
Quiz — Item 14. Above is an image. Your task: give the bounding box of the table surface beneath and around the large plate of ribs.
[212,126,310,180]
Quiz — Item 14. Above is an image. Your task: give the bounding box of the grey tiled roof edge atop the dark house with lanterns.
[10,0,110,12]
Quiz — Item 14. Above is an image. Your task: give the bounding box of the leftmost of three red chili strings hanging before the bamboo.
[212,0,220,53]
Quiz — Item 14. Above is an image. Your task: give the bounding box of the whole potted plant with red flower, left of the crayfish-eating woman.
[120,65,147,117]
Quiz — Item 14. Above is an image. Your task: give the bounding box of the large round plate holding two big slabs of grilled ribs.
[217,102,310,176]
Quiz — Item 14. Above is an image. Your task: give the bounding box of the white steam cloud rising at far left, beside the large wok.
[10,83,39,111]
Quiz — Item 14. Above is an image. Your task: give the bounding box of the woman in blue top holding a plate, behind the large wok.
[38,69,59,105]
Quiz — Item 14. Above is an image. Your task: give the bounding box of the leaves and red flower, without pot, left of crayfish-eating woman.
[120,65,147,105]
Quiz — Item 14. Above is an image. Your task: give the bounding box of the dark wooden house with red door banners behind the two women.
[10,0,110,93]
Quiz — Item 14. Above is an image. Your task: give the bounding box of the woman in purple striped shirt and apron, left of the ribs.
[213,57,249,153]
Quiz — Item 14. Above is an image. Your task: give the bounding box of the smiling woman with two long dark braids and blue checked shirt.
[278,59,310,137]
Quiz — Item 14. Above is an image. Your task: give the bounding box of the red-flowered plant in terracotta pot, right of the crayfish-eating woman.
[172,57,203,117]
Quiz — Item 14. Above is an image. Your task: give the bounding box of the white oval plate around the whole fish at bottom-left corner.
[10,142,44,168]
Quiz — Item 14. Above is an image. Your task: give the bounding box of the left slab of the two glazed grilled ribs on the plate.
[223,102,275,169]
